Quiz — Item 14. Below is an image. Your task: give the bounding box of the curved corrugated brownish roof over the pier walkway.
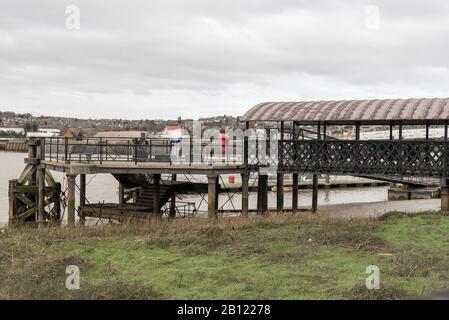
[242,98,449,122]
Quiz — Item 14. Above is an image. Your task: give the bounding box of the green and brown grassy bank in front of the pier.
[0,213,449,299]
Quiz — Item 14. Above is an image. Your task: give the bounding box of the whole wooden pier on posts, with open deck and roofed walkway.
[9,99,449,225]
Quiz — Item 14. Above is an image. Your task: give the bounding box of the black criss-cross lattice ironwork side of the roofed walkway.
[279,140,449,177]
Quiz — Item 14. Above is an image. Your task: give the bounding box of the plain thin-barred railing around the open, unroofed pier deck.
[43,137,254,164]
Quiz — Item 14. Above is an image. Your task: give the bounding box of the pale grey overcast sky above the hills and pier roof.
[0,0,449,119]
